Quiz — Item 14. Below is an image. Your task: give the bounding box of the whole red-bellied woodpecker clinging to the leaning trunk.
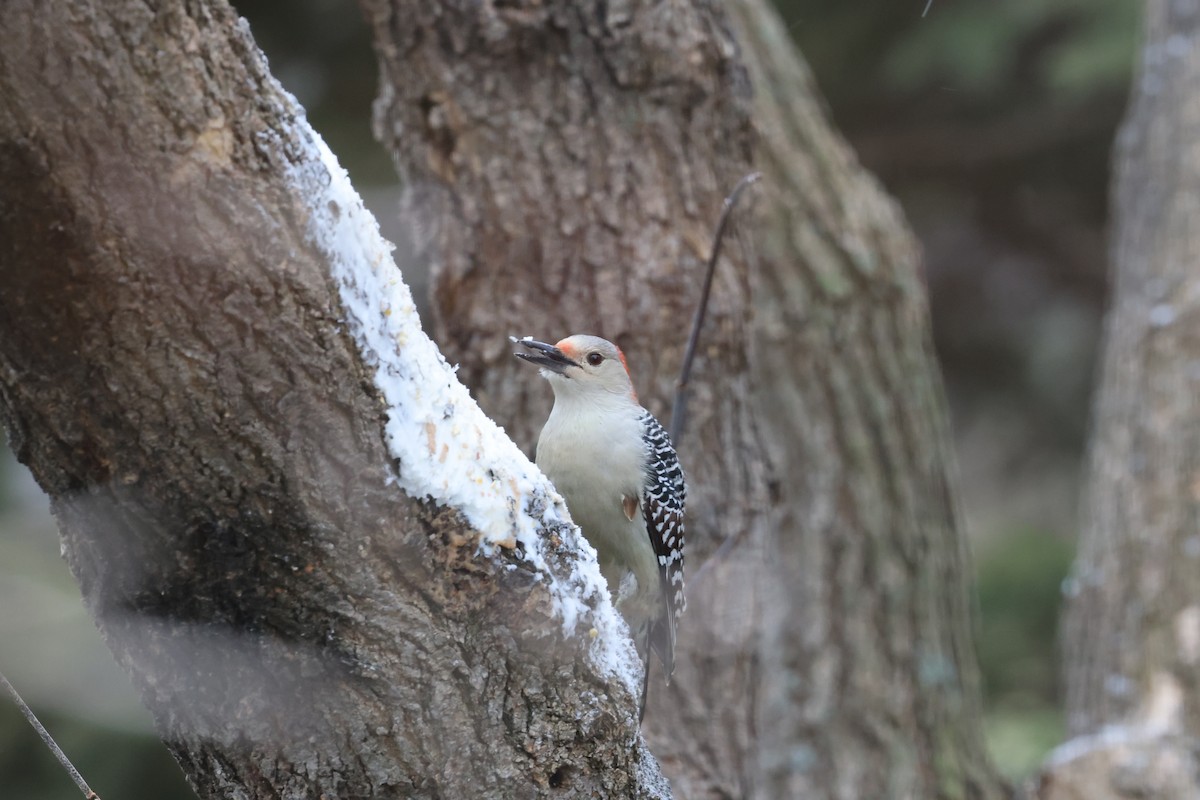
[512,335,686,700]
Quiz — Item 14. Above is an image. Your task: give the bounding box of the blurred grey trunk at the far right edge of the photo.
[1040,0,1200,800]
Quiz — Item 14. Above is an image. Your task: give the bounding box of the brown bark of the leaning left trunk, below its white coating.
[0,0,661,799]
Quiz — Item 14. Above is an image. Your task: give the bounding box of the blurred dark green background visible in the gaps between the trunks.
[0,0,1140,800]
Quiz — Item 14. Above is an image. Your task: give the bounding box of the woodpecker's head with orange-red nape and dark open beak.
[510,333,637,403]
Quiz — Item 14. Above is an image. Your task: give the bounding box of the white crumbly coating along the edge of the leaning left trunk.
[274,100,642,697]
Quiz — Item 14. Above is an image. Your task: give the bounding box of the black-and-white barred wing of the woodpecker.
[642,411,688,681]
